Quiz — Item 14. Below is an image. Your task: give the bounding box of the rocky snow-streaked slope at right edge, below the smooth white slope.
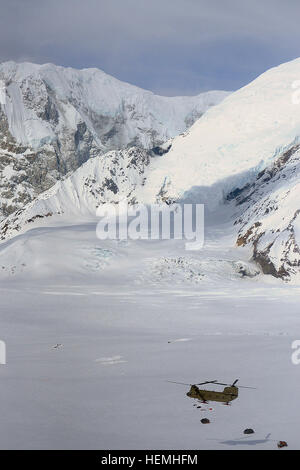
[236,143,300,280]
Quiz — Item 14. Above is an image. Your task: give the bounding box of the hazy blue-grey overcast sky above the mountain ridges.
[0,0,300,95]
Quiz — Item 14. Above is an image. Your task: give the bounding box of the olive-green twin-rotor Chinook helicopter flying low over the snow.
[168,379,254,405]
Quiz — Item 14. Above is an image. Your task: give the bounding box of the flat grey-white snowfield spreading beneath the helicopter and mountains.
[0,207,300,449]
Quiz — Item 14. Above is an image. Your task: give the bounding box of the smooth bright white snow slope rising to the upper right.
[139,59,300,208]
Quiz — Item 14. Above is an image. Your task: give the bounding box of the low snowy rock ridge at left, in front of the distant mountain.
[0,147,152,240]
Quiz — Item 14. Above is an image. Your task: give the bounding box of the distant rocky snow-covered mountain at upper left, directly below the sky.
[0,62,228,219]
